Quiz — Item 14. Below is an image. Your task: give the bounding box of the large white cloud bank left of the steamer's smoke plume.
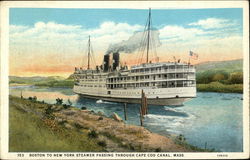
[10,22,143,61]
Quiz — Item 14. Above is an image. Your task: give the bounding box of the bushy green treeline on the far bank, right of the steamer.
[196,70,243,84]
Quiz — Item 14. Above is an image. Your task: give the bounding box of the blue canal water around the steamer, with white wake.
[10,86,243,152]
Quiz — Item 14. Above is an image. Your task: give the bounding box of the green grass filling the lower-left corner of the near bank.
[9,97,104,152]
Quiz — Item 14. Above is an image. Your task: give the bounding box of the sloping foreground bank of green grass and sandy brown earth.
[9,96,212,152]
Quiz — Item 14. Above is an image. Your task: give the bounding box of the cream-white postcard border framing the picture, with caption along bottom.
[0,1,250,159]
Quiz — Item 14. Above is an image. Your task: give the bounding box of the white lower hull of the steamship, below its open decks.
[74,86,196,106]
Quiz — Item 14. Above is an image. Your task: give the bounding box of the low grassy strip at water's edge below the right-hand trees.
[197,82,243,93]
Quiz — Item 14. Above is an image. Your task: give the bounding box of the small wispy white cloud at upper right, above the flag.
[189,18,235,29]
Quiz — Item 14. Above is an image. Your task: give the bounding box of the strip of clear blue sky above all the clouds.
[10,8,242,28]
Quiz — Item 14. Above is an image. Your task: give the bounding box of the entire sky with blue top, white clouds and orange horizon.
[9,8,243,77]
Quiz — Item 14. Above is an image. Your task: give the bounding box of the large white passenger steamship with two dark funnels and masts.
[73,11,196,106]
